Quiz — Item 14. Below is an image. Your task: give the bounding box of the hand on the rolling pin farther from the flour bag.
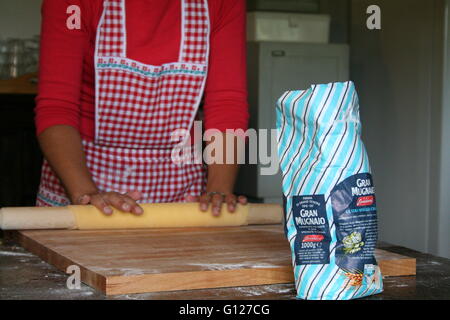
[74,191,144,215]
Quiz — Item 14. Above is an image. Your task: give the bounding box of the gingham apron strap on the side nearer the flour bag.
[179,0,210,64]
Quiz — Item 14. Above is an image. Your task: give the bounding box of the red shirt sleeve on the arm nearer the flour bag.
[204,0,249,131]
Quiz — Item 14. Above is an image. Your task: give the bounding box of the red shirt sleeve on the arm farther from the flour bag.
[35,0,88,134]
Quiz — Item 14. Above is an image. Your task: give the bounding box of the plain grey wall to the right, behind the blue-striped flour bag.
[350,0,450,257]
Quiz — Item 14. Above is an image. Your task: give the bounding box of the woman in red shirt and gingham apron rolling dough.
[35,0,248,215]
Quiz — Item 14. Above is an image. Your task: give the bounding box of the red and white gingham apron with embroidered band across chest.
[37,0,210,206]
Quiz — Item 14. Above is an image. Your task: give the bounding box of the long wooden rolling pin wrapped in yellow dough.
[0,203,282,230]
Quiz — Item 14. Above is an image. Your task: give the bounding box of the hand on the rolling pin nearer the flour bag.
[186,192,247,216]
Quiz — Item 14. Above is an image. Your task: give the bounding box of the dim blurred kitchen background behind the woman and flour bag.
[0,0,450,258]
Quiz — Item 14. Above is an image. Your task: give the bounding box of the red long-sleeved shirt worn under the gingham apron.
[35,0,248,140]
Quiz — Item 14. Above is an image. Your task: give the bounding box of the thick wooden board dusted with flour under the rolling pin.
[15,225,415,295]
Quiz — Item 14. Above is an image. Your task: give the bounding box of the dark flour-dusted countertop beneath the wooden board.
[0,237,450,300]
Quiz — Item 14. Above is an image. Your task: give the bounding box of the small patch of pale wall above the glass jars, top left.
[0,0,42,39]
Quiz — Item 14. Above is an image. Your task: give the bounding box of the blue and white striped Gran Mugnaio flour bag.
[277,81,383,300]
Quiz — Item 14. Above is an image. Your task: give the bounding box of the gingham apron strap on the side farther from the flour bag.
[96,0,127,57]
